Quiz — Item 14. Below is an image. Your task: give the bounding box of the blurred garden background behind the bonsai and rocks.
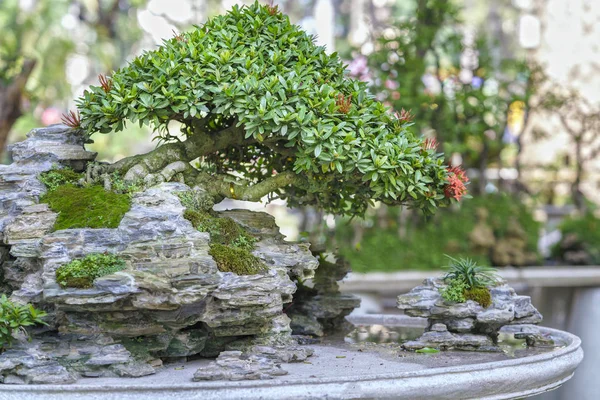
[0,0,600,399]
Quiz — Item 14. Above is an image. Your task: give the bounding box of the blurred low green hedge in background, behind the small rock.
[335,194,540,272]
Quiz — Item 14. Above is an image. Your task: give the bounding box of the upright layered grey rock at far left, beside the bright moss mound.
[0,125,96,297]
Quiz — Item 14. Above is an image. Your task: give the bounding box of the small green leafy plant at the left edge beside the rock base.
[0,294,46,350]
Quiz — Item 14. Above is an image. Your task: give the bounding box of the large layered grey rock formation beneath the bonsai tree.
[0,126,318,383]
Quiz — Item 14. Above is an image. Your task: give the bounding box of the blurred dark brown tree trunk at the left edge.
[0,60,35,154]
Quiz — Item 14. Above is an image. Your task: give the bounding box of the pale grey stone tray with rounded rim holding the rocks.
[0,328,583,400]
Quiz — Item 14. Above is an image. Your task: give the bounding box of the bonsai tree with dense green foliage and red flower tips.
[65,3,467,216]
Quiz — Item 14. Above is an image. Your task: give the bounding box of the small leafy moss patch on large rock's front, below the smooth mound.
[56,254,126,288]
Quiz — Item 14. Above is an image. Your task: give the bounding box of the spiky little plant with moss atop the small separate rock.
[440,257,498,307]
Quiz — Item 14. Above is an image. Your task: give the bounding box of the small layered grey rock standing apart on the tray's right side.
[398,278,542,351]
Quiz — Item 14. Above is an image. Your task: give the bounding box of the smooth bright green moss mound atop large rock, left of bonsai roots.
[40,184,131,230]
